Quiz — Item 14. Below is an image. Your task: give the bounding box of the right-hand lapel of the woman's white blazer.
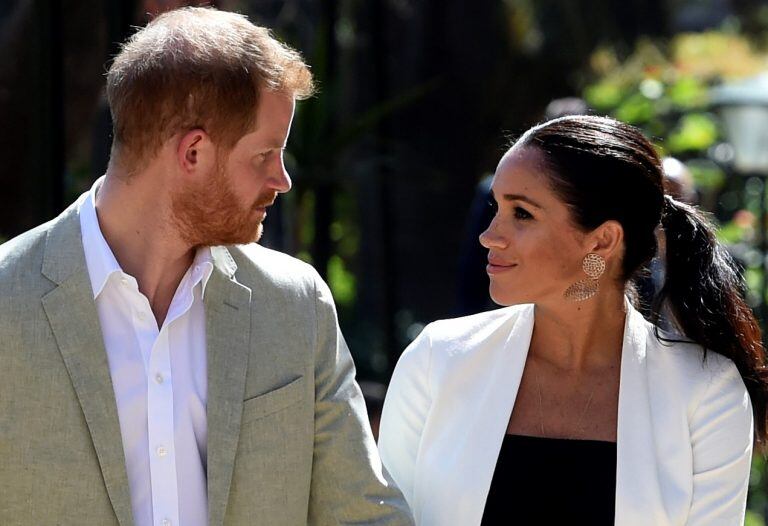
[615,300,665,526]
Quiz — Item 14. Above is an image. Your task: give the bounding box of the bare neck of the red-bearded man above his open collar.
[94,172,195,327]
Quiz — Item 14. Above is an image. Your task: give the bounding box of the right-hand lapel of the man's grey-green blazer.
[205,247,251,526]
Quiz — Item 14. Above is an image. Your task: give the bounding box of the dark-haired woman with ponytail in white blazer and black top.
[379,116,767,526]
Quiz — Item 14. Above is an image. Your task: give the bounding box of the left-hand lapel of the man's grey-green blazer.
[42,203,133,526]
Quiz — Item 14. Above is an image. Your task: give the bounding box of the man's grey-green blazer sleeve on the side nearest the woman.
[307,275,413,526]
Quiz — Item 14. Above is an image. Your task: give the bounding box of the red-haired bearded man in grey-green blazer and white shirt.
[0,8,412,526]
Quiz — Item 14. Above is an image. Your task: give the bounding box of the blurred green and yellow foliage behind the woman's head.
[583,28,768,248]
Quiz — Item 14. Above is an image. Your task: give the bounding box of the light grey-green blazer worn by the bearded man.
[0,198,412,526]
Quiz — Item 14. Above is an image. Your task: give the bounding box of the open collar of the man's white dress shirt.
[78,177,213,299]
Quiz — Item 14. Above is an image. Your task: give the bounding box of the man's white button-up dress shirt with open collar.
[79,181,213,526]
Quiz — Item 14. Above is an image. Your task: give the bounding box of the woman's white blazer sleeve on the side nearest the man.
[379,327,432,509]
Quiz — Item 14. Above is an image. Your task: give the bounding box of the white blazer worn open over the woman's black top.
[379,301,753,526]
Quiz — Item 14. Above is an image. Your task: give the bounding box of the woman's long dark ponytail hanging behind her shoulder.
[652,196,768,442]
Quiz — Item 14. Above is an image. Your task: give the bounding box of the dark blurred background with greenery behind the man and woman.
[0,0,768,526]
